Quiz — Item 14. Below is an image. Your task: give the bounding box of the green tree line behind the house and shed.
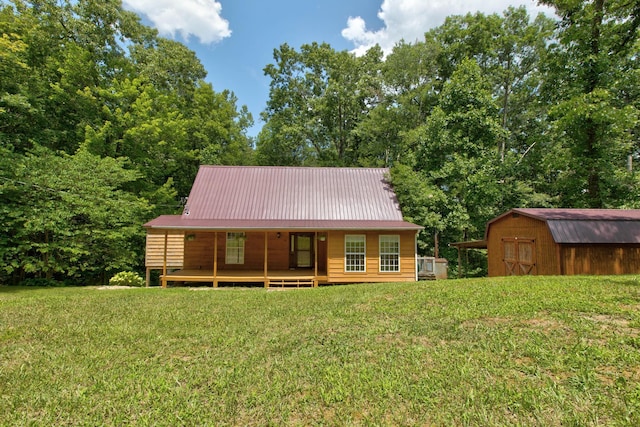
[0,0,640,283]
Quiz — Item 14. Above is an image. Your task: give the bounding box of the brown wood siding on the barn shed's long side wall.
[560,244,640,275]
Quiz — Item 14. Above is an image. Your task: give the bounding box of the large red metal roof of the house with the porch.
[145,166,422,230]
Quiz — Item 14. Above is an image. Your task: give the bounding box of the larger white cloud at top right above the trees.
[342,0,553,54]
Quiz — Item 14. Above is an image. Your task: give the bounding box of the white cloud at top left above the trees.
[122,0,231,43]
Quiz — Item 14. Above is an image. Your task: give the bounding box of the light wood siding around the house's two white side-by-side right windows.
[327,231,416,283]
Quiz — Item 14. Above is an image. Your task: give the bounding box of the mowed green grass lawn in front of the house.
[0,276,640,426]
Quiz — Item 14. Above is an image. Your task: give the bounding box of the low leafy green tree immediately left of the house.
[0,148,148,283]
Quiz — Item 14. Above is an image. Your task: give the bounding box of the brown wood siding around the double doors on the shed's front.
[487,215,560,277]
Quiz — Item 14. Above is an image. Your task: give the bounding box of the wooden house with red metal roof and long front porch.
[145,166,422,287]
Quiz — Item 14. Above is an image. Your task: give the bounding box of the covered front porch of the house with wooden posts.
[156,229,328,288]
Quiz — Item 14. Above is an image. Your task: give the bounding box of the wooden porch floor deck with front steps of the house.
[160,269,328,288]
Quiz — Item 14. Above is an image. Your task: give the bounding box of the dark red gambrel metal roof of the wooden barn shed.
[485,208,640,244]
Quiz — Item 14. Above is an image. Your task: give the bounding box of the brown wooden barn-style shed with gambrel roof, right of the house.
[485,209,640,276]
